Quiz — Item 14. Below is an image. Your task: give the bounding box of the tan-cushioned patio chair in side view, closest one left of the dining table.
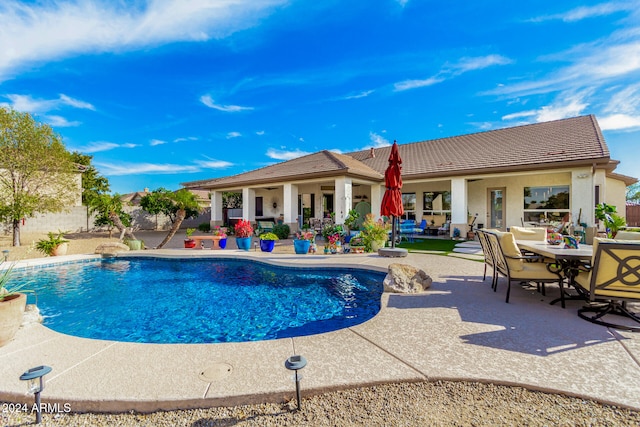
[486,231,564,307]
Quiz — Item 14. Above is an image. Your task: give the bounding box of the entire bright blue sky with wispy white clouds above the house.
[0,0,640,193]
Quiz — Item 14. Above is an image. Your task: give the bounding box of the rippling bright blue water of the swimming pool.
[14,258,384,343]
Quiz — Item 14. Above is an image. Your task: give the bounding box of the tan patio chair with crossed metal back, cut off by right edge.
[574,238,640,332]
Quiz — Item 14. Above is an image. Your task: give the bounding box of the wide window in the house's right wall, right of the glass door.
[524,185,569,223]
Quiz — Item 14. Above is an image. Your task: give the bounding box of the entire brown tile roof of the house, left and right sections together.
[182,115,610,188]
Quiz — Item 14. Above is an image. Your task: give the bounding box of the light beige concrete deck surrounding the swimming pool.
[0,249,640,412]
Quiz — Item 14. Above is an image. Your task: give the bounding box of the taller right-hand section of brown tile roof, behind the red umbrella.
[348,115,609,179]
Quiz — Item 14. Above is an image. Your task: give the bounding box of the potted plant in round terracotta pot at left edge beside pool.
[0,261,29,347]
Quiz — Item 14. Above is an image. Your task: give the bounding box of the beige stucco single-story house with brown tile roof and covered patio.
[182,115,637,233]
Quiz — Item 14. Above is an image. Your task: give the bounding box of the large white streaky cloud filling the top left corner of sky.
[0,0,288,81]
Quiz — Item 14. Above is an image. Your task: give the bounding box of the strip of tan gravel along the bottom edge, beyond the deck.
[0,381,640,427]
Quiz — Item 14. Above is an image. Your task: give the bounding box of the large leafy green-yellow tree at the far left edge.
[0,107,79,246]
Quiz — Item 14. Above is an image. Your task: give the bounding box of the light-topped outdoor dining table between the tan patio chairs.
[517,240,593,308]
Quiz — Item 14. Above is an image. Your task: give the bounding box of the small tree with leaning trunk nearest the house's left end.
[140,188,200,249]
